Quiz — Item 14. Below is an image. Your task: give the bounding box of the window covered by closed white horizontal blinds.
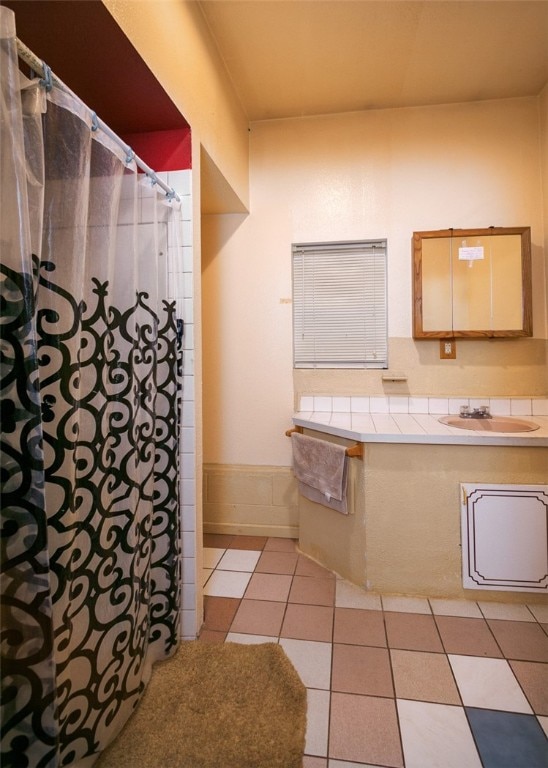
[292,240,388,368]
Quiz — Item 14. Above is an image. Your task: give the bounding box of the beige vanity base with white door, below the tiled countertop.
[298,438,548,603]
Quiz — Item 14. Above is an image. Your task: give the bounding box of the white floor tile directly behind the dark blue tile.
[449,654,532,714]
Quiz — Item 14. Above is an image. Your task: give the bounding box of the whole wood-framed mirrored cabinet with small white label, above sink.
[413,227,533,339]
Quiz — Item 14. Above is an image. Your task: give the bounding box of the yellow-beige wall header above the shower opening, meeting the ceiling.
[103,0,249,210]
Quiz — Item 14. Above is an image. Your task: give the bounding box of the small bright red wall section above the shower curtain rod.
[120,128,192,172]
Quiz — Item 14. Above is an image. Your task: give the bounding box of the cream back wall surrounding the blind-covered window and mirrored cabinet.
[202,95,548,466]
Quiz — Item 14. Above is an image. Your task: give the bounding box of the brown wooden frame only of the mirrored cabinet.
[413,227,533,339]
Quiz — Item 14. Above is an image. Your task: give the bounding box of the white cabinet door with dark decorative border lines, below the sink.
[461,483,548,594]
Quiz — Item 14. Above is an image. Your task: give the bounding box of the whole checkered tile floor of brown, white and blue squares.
[200,534,548,768]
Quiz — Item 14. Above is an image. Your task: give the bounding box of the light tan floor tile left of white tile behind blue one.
[390,650,461,705]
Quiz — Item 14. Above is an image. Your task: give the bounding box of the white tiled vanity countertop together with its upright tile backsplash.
[293,395,548,447]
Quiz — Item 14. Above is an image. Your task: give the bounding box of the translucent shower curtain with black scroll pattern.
[0,7,180,768]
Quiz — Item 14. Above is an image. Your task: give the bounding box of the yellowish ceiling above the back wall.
[199,0,548,121]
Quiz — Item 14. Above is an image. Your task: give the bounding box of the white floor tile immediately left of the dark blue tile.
[397,699,481,768]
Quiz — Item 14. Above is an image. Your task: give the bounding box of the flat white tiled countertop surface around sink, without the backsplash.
[293,411,548,447]
